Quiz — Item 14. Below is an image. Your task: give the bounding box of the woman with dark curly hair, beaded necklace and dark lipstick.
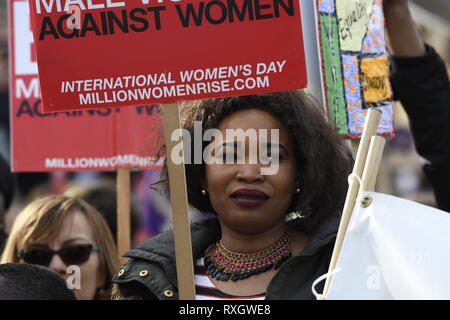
[113,91,352,299]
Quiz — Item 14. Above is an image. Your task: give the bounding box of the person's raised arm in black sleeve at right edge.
[383,0,450,212]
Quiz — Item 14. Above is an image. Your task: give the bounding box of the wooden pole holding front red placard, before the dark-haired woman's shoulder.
[163,103,195,300]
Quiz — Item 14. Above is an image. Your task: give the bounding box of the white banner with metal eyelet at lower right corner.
[316,192,450,300]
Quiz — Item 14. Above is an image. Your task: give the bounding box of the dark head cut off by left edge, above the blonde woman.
[0,155,16,255]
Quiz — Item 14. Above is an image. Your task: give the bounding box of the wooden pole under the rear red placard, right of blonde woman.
[117,168,131,263]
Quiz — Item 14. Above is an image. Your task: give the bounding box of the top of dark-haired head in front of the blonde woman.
[0,263,76,300]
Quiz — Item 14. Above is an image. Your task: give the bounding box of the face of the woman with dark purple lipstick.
[205,109,298,234]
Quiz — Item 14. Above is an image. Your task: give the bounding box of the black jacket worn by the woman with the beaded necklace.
[113,217,339,300]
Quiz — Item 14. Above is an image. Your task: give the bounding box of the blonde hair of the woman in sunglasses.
[0,195,120,298]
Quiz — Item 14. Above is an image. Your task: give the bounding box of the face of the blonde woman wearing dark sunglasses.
[28,211,102,300]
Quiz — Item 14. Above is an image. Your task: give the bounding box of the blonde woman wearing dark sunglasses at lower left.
[1,195,119,300]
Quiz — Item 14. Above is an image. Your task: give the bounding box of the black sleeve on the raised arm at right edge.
[391,45,450,211]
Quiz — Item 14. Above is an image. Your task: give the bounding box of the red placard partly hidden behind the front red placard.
[8,0,163,172]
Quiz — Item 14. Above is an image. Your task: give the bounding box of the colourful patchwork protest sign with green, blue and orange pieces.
[316,0,394,138]
